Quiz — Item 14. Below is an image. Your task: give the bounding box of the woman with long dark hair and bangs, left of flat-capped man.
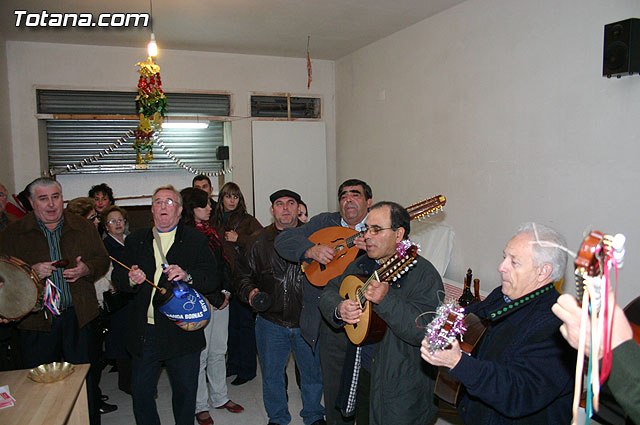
[213,182,262,385]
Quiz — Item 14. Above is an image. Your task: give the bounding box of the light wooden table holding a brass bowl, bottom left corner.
[0,364,89,425]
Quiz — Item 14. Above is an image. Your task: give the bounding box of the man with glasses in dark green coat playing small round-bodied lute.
[319,202,443,425]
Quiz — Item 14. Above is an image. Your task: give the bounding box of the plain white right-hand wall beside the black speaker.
[336,0,640,304]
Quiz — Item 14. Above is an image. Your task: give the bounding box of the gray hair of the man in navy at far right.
[516,222,567,282]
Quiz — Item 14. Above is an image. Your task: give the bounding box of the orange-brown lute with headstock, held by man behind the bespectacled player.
[302,195,447,286]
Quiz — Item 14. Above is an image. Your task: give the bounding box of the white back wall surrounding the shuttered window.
[7,40,335,209]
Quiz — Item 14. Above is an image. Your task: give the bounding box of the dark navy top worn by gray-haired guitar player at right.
[451,287,576,425]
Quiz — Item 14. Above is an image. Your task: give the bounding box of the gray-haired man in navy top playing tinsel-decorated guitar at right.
[421,223,576,425]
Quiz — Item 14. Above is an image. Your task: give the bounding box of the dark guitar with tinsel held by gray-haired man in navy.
[433,313,487,406]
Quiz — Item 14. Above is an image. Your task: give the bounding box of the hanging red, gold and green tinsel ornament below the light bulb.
[133,56,167,164]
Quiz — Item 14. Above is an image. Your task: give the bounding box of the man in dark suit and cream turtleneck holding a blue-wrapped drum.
[112,186,220,425]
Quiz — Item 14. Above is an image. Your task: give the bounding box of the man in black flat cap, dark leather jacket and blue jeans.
[234,189,325,425]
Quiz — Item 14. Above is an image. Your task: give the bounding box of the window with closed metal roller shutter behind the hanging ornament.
[37,90,230,174]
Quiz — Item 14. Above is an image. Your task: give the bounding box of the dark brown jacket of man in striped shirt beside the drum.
[0,212,109,332]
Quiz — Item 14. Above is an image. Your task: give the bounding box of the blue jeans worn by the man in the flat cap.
[256,315,324,425]
